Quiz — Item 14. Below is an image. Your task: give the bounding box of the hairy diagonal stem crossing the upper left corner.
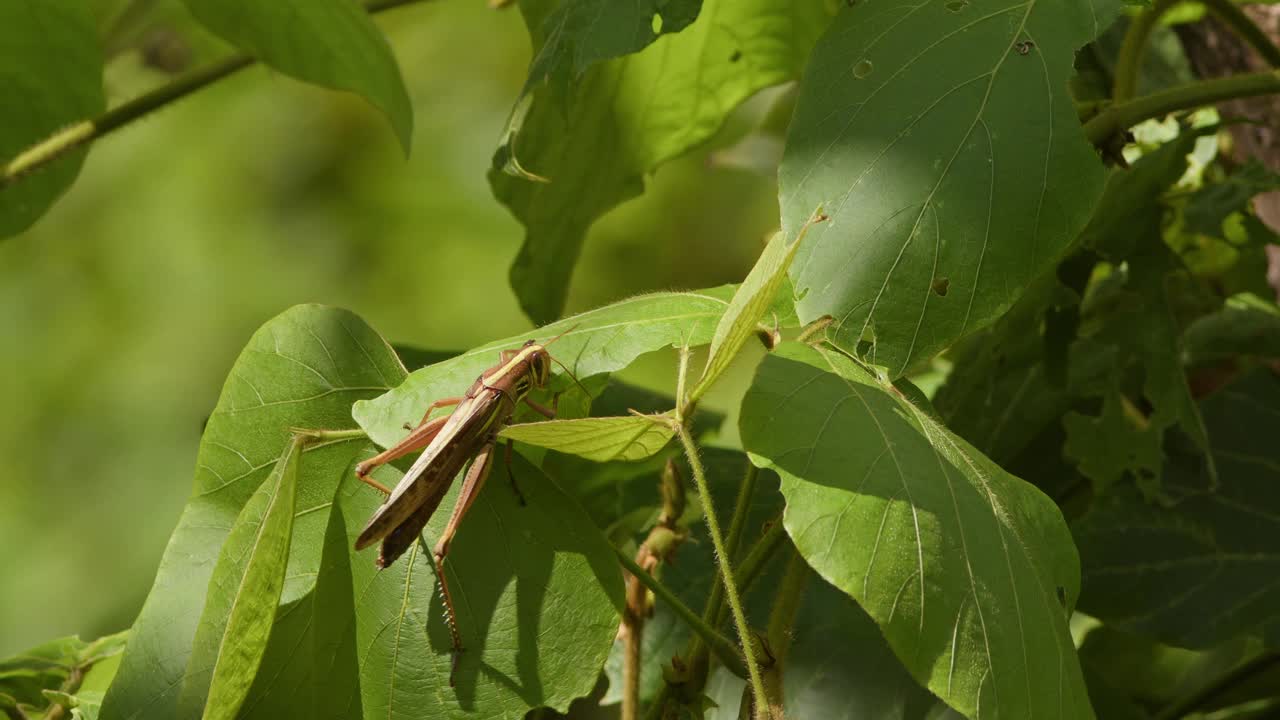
[0,0,422,190]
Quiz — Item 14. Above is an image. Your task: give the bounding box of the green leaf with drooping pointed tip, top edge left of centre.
[183,0,413,152]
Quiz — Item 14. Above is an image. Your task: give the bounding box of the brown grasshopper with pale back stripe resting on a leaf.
[356,331,568,685]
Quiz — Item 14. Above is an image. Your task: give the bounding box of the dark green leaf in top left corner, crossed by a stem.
[0,0,106,238]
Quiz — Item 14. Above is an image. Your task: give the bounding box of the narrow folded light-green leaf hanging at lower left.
[179,439,302,720]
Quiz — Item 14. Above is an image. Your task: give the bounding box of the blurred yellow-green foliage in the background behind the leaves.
[0,0,777,656]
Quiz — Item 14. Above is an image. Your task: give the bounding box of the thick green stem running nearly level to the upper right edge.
[1084,70,1280,145]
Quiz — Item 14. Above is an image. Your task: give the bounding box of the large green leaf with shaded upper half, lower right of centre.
[740,343,1093,719]
